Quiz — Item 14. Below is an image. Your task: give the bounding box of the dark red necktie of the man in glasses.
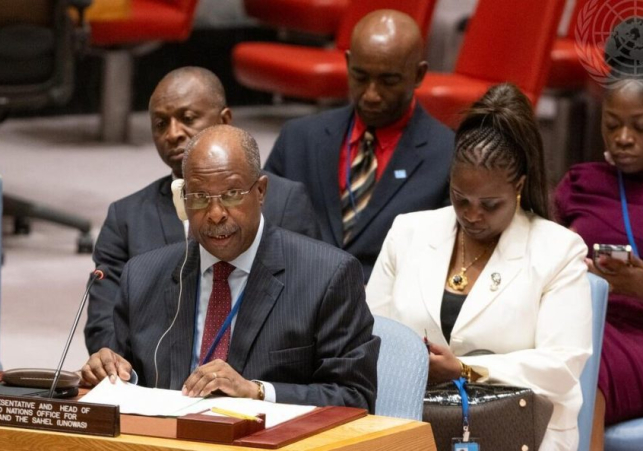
[199,262,234,365]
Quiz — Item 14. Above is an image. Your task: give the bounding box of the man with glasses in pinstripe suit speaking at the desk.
[82,125,379,412]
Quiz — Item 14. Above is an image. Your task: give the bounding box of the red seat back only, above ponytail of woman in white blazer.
[455,0,565,96]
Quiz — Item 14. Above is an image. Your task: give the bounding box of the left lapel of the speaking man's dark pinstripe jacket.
[166,241,200,390]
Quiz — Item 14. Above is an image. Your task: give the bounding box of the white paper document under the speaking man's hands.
[80,378,315,428]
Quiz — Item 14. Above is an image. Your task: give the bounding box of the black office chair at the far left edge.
[0,0,93,253]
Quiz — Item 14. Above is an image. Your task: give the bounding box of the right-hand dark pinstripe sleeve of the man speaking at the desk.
[268,258,380,412]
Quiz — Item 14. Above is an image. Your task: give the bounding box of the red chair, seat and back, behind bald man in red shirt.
[232,0,436,99]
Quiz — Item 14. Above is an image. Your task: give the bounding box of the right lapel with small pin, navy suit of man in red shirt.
[346,106,428,245]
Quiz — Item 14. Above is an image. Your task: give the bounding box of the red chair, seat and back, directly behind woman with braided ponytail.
[416,0,565,128]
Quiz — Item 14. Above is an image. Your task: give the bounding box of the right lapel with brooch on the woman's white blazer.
[452,210,529,335]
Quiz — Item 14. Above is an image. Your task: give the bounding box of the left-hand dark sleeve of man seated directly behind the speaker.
[85,204,130,354]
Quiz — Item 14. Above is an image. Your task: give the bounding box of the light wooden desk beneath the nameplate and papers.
[0,415,436,451]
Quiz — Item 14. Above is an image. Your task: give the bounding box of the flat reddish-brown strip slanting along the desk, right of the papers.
[233,406,368,449]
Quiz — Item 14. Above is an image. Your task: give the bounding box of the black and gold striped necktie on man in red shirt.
[341,129,377,243]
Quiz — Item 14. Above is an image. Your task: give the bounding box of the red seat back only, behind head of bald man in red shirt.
[335,0,437,50]
